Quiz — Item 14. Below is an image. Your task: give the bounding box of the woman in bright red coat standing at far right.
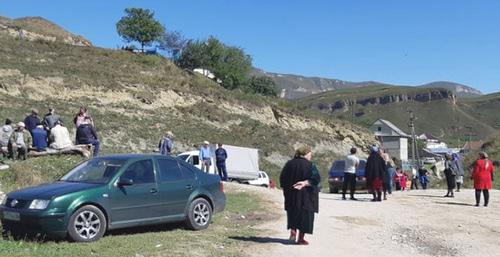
[471,152,495,206]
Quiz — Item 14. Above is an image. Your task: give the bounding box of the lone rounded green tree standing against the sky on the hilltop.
[116,8,165,52]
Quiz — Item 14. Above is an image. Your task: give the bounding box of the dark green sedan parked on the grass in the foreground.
[0,154,226,242]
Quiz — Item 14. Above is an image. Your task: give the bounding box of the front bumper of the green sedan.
[0,206,67,238]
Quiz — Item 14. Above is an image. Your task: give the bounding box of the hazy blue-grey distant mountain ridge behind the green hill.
[256,70,482,99]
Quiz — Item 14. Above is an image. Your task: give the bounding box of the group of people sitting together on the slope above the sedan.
[0,107,100,160]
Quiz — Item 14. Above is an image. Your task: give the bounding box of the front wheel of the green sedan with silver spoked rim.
[68,205,107,242]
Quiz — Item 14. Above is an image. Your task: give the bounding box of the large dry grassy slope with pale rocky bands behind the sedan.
[0,27,375,184]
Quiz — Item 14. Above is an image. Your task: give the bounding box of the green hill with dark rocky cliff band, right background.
[297,86,496,142]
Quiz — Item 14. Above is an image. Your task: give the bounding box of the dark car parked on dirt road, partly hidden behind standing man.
[328,160,366,193]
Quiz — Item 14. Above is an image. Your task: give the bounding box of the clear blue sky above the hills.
[0,0,500,93]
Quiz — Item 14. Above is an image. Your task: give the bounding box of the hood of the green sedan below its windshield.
[7,181,103,200]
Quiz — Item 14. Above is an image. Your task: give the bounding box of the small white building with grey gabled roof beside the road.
[371,119,411,162]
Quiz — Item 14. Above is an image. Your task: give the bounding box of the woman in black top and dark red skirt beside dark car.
[365,146,386,202]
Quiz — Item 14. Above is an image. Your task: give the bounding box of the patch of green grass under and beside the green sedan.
[0,190,262,257]
